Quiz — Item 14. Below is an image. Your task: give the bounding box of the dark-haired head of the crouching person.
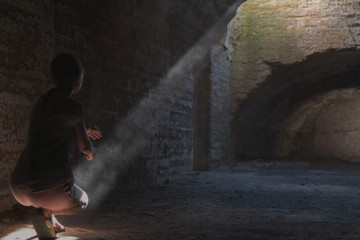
[51,53,84,93]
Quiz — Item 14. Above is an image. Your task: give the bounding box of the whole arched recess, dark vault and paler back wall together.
[231,49,360,161]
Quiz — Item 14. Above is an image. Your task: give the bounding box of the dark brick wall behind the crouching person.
[0,0,242,210]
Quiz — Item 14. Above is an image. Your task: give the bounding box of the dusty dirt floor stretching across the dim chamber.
[0,162,360,240]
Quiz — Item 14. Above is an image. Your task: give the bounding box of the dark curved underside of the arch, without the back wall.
[231,49,360,161]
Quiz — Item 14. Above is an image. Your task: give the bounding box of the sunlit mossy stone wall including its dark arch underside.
[229,0,360,162]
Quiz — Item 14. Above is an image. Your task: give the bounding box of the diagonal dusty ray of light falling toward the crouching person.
[74,0,244,207]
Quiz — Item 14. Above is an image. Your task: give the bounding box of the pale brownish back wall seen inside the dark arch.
[281,88,360,162]
